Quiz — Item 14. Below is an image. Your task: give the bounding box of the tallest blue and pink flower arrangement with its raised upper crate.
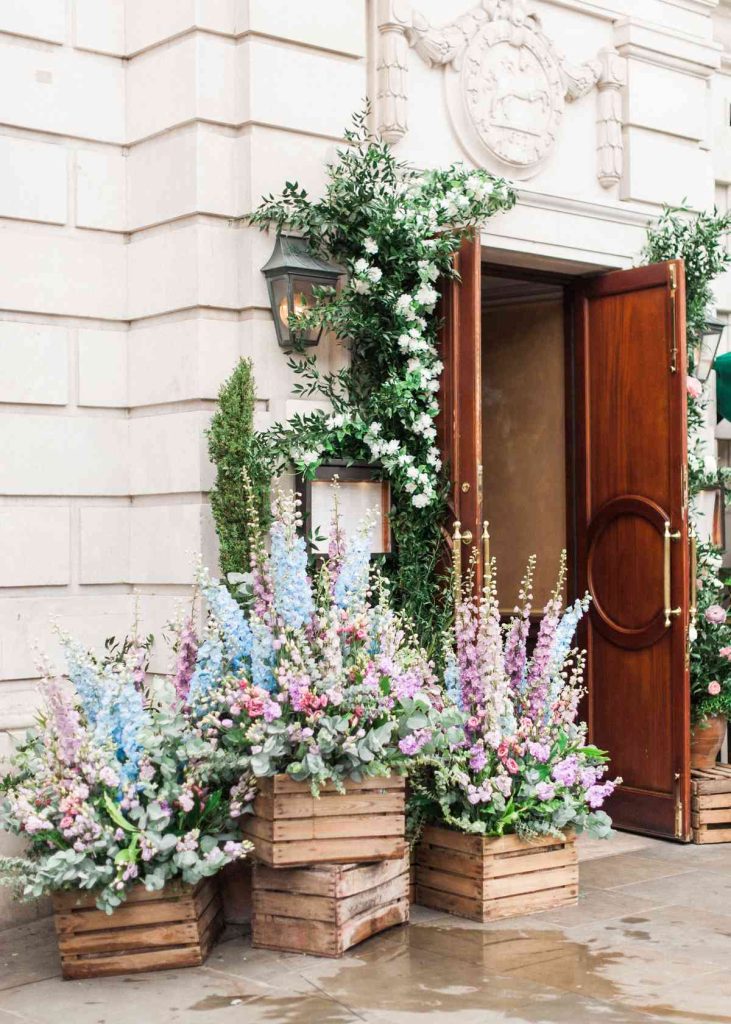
[178,494,454,866]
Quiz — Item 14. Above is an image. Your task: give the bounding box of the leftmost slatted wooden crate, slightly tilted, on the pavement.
[53,879,223,978]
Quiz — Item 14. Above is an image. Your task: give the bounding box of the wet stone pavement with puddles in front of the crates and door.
[0,835,731,1024]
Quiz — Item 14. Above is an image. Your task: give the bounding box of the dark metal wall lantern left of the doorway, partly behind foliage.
[261,234,342,349]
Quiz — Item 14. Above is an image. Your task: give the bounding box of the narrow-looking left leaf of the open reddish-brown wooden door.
[437,237,482,588]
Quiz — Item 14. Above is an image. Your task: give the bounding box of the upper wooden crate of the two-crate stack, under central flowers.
[242,775,406,867]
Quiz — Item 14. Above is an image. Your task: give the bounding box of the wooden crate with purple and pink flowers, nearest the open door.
[413,558,620,920]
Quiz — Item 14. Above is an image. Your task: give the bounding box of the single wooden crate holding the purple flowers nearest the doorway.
[416,826,578,922]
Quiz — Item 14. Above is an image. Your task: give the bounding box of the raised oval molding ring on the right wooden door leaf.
[587,495,669,650]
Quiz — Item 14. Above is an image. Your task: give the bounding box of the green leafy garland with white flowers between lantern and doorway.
[250,113,515,651]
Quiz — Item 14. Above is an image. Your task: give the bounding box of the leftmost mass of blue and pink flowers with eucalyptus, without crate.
[0,635,250,913]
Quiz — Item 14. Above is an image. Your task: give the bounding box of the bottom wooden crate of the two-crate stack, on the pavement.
[252,853,409,956]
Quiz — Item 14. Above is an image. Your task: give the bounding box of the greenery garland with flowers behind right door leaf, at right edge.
[642,207,731,722]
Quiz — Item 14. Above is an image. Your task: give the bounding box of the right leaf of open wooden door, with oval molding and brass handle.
[574,261,690,840]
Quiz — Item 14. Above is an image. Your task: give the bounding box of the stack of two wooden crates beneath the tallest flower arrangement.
[243,775,410,956]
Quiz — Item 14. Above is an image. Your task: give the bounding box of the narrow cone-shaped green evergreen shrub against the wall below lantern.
[208,359,269,590]
